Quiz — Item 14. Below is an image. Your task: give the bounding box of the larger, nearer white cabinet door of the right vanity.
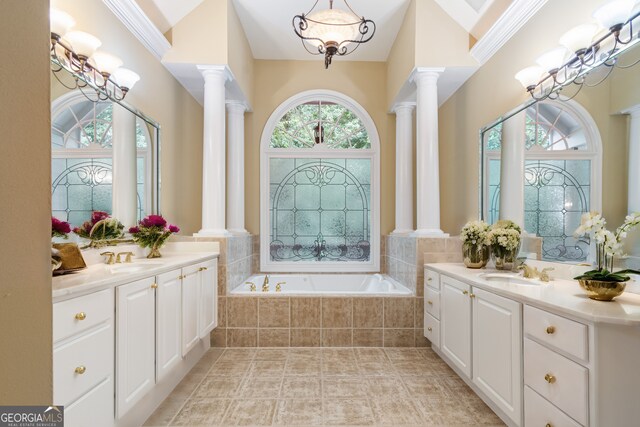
[472,288,522,425]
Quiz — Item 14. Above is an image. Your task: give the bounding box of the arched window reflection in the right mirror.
[483,100,602,261]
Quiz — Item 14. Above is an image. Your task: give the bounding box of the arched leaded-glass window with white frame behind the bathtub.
[260,91,380,271]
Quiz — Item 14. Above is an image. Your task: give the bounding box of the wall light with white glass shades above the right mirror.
[515,0,640,101]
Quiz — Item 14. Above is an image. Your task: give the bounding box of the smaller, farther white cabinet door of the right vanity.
[440,276,471,378]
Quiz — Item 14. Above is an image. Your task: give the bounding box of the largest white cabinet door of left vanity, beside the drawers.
[116,278,156,418]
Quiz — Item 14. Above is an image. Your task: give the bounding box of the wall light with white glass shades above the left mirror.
[49,9,140,101]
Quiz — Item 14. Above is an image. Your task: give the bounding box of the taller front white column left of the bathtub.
[196,66,229,237]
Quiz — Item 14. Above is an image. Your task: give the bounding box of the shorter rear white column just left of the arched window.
[227,101,248,235]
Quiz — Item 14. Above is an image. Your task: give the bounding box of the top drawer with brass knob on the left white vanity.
[53,289,114,342]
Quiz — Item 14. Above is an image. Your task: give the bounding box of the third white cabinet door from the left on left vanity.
[182,265,200,357]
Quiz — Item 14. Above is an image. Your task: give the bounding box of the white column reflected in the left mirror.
[111,102,138,227]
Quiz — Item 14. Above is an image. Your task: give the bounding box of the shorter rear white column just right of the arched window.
[393,102,415,234]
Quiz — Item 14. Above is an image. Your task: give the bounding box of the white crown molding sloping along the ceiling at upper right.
[471,0,548,65]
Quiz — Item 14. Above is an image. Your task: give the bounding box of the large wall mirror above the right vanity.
[480,46,640,263]
